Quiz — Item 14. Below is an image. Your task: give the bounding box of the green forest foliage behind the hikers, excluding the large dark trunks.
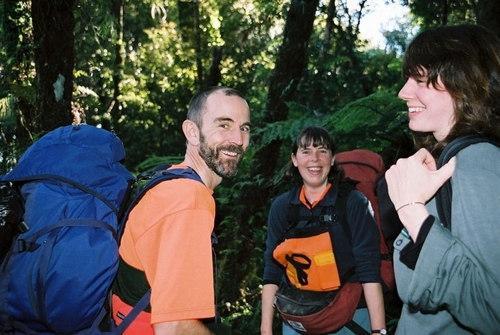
[5,0,484,335]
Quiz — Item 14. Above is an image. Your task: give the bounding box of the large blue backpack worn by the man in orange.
[0,125,135,334]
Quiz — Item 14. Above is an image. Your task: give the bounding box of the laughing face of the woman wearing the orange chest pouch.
[292,143,334,187]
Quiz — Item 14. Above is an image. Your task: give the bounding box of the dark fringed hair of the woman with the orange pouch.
[286,126,344,185]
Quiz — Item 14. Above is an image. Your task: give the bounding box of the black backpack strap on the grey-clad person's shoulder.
[436,134,500,229]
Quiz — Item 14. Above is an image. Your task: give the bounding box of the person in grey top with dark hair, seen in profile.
[386,25,500,335]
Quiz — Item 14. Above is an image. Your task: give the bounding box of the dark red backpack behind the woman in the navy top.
[335,149,396,291]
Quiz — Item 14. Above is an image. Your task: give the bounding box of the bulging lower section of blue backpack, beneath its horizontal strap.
[7,219,118,334]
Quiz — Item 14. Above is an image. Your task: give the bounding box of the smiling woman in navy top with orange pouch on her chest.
[261,126,385,335]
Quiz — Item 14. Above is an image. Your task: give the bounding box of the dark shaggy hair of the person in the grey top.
[403,24,500,156]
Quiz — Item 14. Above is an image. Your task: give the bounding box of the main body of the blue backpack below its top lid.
[0,181,118,334]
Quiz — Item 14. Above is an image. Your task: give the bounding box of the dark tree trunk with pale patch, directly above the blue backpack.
[32,0,75,132]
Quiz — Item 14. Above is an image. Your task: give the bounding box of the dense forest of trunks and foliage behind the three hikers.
[0,0,500,335]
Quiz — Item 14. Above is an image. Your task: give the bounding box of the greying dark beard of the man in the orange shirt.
[198,134,245,178]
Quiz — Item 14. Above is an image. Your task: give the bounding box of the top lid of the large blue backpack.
[2,124,135,213]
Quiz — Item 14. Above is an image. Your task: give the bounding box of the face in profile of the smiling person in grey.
[398,73,455,142]
